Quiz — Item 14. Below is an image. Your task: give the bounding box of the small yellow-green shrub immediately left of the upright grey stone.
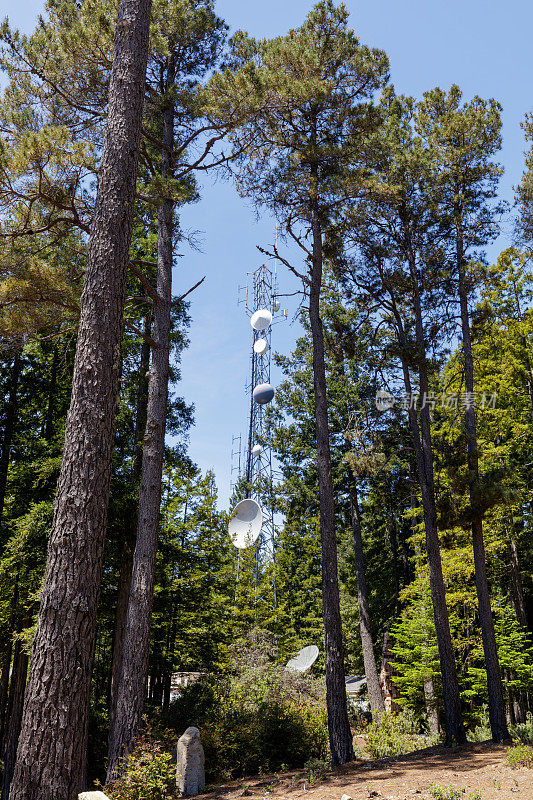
[106,733,178,800]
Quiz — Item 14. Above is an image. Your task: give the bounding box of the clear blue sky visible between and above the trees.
[2,0,533,507]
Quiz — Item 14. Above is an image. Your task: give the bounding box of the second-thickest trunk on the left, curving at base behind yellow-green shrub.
[107,97,174,782]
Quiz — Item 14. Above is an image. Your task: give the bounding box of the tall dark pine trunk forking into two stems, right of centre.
[388,278,466,746]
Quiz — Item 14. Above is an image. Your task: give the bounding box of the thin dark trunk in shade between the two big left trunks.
[109,311,152,730]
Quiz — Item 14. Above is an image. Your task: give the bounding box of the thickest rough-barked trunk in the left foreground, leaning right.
[10,0,151,800]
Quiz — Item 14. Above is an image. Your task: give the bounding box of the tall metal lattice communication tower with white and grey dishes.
[230,264,280,568]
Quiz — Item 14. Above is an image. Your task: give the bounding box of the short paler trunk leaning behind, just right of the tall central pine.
[350,482,385,719]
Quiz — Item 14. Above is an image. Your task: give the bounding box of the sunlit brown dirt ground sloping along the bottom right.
[203,743,533,800]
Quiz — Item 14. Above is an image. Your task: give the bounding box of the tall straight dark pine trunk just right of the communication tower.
[309,191,354,765]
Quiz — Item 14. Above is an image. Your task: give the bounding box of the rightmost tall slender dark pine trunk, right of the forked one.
[457,230,509,742]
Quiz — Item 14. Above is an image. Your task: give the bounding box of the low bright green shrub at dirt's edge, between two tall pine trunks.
[365,709,440,758]
